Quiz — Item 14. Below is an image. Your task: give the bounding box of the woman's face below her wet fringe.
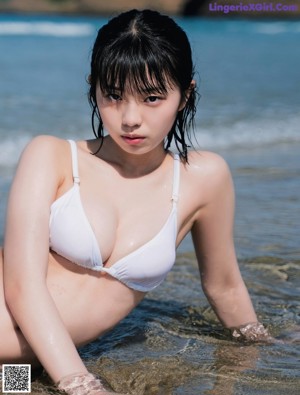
[96,82,183,154]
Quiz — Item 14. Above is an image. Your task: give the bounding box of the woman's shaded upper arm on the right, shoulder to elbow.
[192,154,241,292]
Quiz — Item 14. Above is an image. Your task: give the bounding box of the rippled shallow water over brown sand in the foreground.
[27,253,300,395]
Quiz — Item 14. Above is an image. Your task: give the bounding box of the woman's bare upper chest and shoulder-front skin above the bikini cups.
[54,141,205,256]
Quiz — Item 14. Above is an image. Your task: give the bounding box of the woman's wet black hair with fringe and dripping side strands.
[88,10,197,161]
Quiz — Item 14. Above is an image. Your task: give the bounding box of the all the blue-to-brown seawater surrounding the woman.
[0,15,300,395]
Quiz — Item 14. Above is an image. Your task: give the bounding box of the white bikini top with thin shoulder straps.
[49,140,180,292]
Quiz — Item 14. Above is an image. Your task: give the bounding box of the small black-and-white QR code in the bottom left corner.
[2,364,31,394]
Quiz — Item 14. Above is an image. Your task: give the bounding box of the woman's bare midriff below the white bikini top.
[47,253,145,345]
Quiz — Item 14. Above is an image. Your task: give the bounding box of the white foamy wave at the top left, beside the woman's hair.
[0,21,95,37]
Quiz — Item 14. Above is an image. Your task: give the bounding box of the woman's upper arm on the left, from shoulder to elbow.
[4,136,65,290]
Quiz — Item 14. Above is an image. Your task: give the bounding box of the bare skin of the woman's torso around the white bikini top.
[47,141,211,344]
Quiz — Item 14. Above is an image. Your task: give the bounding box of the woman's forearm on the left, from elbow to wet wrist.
[7,286,87,382]
